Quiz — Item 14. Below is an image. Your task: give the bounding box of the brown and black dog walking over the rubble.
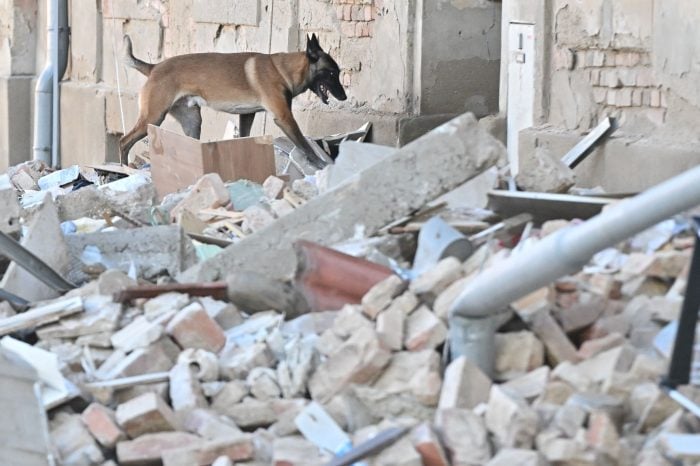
[119,34,347,168]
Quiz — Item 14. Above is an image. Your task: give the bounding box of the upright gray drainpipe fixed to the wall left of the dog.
[33,0,68,167]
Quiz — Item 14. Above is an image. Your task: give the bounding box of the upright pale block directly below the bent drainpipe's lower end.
[438,356,491,409]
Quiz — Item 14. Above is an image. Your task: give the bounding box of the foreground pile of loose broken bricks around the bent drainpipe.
[21,217,700,466]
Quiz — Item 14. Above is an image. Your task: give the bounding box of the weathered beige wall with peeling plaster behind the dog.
[0,0,500,168]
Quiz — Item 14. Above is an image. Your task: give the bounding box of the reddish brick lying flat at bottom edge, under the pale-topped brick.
[117,432,202,466]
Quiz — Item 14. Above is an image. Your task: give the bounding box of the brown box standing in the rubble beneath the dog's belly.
[148,125,276,199]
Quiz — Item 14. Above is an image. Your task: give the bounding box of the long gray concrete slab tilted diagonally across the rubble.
[178,114,505,282]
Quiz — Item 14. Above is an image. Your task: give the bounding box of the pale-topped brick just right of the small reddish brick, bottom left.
[116,393,178,438]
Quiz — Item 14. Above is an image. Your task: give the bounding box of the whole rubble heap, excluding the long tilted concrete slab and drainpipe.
[0,115,700,466]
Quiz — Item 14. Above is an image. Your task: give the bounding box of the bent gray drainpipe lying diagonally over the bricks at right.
[449,167,700,374]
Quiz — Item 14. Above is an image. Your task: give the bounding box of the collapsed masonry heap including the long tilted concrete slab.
[0,116,700,466]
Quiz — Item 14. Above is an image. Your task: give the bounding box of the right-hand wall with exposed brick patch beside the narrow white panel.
[500,0,700,190]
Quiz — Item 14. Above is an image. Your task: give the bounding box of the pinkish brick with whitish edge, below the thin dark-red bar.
[167,303,226,353]
